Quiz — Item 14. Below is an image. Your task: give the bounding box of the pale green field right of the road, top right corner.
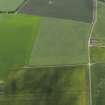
[92,1,105,41]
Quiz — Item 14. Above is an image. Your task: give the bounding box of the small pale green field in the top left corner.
[0,0,24,11]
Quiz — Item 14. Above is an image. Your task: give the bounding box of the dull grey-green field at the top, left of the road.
[19,0,93,22]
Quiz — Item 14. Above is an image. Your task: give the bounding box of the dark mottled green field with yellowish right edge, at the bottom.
[0,66,89,105]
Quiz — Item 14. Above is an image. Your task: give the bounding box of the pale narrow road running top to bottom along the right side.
[88,0,97,105]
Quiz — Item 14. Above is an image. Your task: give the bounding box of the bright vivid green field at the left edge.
[0,15,40,79]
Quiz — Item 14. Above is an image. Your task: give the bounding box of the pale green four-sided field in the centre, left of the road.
[30,18,90,65]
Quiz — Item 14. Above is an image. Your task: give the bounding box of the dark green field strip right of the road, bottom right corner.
[92,64,105,105]
